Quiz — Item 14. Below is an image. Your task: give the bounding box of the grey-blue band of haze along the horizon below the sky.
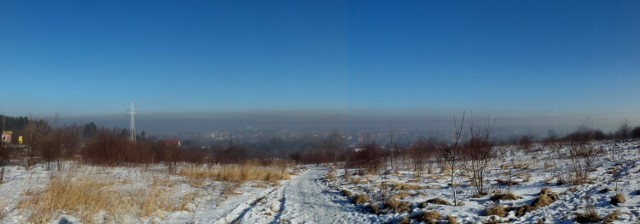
[39,108,640,140]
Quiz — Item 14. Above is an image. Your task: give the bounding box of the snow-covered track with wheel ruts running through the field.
[233,167,379,223]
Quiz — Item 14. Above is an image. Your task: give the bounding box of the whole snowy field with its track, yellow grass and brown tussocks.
[0,141,640,224]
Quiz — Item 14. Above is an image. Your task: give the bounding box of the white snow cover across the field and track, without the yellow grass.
[0,141,640,223]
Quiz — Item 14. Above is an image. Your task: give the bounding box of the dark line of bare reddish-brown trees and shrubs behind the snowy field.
[0,114,640,171]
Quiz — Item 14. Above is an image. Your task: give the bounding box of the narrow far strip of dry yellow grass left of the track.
[178,164,289,184]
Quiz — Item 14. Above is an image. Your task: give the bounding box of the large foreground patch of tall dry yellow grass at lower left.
[18,170,180,223]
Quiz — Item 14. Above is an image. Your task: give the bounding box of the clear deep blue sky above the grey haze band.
[0,0,640,120]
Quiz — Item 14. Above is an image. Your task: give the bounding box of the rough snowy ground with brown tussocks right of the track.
[330,141,640,223]
